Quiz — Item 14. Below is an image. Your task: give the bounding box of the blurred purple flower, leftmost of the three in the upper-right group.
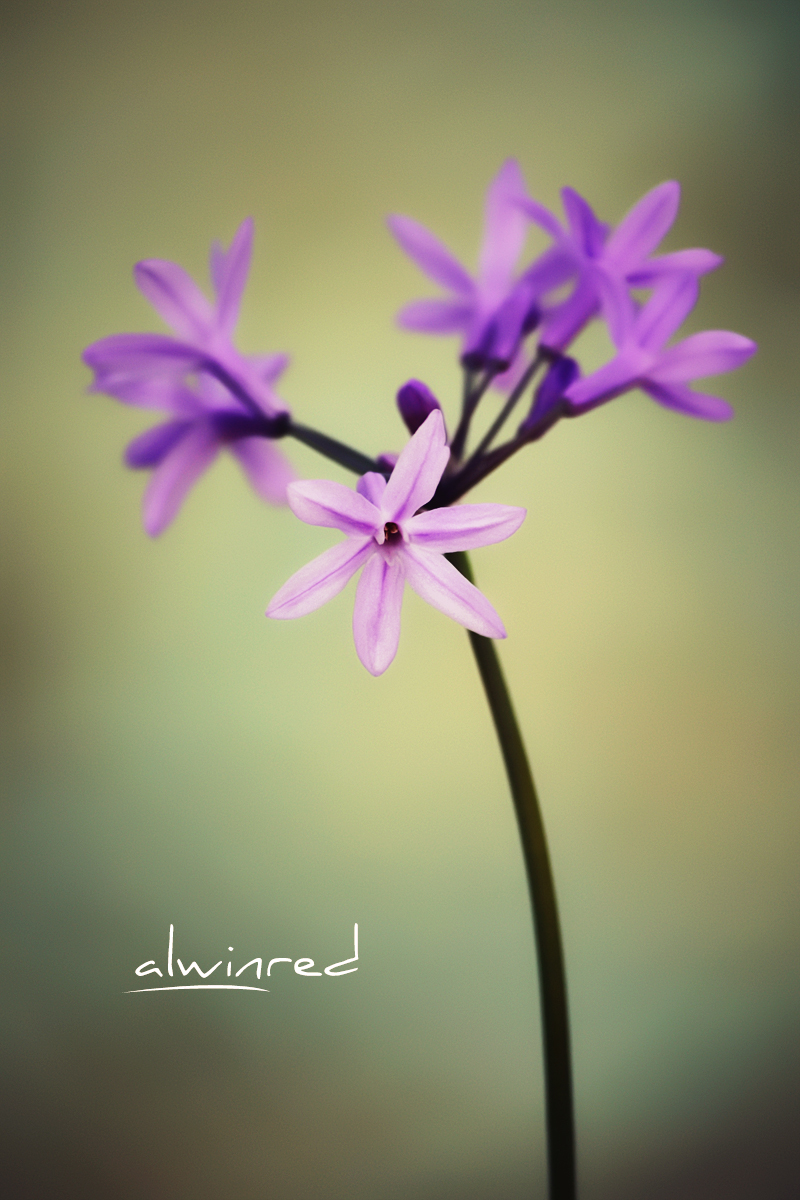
[387,158,537,368]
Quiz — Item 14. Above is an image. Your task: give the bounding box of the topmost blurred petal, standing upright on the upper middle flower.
[479,158,528,305]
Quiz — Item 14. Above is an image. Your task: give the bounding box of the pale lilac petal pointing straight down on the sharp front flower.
[353,553,405,676]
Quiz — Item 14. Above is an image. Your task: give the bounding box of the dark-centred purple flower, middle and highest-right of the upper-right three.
[522,181,722,350]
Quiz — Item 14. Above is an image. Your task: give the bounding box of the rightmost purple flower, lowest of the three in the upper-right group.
[565,275,757,421]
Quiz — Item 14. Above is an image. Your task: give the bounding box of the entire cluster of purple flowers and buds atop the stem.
[84,160,756,674]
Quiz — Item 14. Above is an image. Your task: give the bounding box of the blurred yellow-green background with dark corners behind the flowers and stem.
[0,0,800,1200]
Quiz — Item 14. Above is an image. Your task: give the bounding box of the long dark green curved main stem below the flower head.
[447,551,576,1200]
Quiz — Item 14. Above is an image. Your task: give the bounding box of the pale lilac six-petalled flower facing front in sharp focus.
[266,409,525,676]
